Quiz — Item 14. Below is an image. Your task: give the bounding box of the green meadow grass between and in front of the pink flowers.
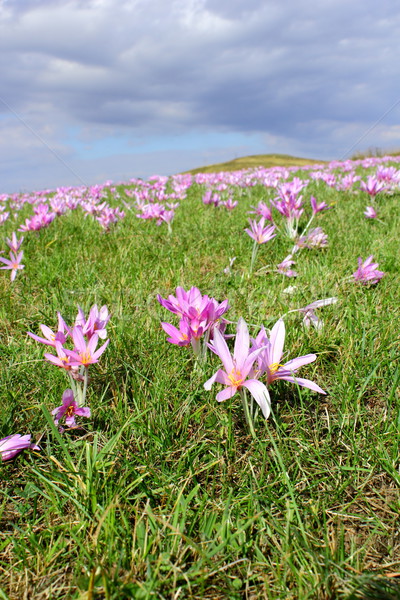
[0,161,400,600]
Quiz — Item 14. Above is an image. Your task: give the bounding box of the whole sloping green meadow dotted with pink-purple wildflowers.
[0,157,400,600]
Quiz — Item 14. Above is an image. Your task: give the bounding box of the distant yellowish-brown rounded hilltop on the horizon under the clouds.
[186,154,328,175]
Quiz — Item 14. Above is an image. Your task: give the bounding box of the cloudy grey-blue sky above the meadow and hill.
[0,0,400,193]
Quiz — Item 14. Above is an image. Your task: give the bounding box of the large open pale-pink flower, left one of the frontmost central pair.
[204,318,271,419]
